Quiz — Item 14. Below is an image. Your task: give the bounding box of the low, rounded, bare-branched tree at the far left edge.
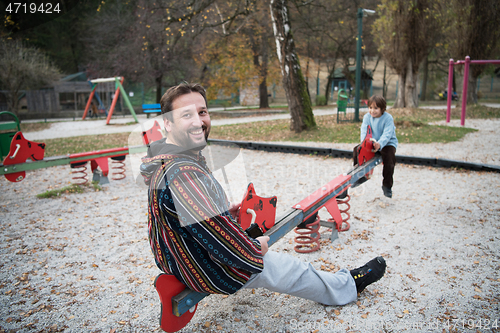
[0,38,59,114]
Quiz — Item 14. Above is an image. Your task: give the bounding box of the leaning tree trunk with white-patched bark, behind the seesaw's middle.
[271,0,316,133]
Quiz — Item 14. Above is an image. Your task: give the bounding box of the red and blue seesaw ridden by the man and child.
[154,128,382,332]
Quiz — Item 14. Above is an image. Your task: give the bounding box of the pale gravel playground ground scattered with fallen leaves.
[0,120,500,332]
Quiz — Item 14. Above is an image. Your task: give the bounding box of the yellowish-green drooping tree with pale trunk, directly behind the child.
[374,0,441,107]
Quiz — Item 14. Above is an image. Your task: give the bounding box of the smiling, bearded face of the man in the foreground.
[165,92,210,152]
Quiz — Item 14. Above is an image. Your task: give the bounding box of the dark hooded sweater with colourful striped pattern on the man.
[141,139,264,294]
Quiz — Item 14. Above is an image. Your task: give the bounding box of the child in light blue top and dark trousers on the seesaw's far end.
[361,95,398,198]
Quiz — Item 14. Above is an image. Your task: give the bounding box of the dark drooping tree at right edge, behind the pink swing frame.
[448,0,500,104]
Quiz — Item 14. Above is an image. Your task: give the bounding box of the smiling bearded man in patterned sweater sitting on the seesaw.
[141,83,386,305]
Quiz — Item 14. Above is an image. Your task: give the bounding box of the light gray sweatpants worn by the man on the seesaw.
[243,251,357,305]
